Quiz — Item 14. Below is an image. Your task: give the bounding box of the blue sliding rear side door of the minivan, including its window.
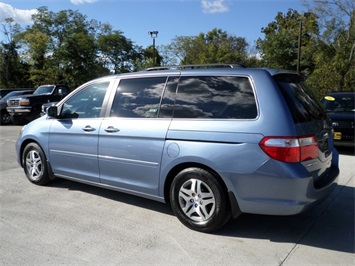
[98,76,178,195]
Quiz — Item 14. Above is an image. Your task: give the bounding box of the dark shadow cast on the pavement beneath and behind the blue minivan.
[51,179,355,253]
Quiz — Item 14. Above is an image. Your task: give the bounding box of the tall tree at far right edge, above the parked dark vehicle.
[303,0,355,95]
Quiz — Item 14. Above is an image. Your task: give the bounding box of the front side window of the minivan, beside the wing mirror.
[61,81,110,118]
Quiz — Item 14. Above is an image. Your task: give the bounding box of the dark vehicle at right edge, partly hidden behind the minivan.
[321,91,355,147]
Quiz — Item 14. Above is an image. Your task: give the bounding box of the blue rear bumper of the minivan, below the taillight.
[229,158,339,215]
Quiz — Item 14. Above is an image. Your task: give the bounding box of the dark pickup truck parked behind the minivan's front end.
[6,85,70,125]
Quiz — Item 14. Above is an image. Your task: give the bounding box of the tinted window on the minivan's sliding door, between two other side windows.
[110,77,167,118]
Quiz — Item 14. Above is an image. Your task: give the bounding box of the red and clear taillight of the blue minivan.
[259,136,318,163]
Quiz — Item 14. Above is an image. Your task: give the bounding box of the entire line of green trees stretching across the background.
[0,0,355,96]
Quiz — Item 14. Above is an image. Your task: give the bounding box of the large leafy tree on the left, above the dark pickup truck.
[17,7,108,88]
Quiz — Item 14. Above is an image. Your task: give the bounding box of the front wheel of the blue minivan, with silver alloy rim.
[22,143,50,185]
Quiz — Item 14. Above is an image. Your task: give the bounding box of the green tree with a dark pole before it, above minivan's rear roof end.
[257,9,318,75]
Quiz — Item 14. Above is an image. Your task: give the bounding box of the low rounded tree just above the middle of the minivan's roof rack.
[169,28,248,64]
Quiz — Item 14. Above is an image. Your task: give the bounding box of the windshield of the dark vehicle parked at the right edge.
[321,93,355,113]
